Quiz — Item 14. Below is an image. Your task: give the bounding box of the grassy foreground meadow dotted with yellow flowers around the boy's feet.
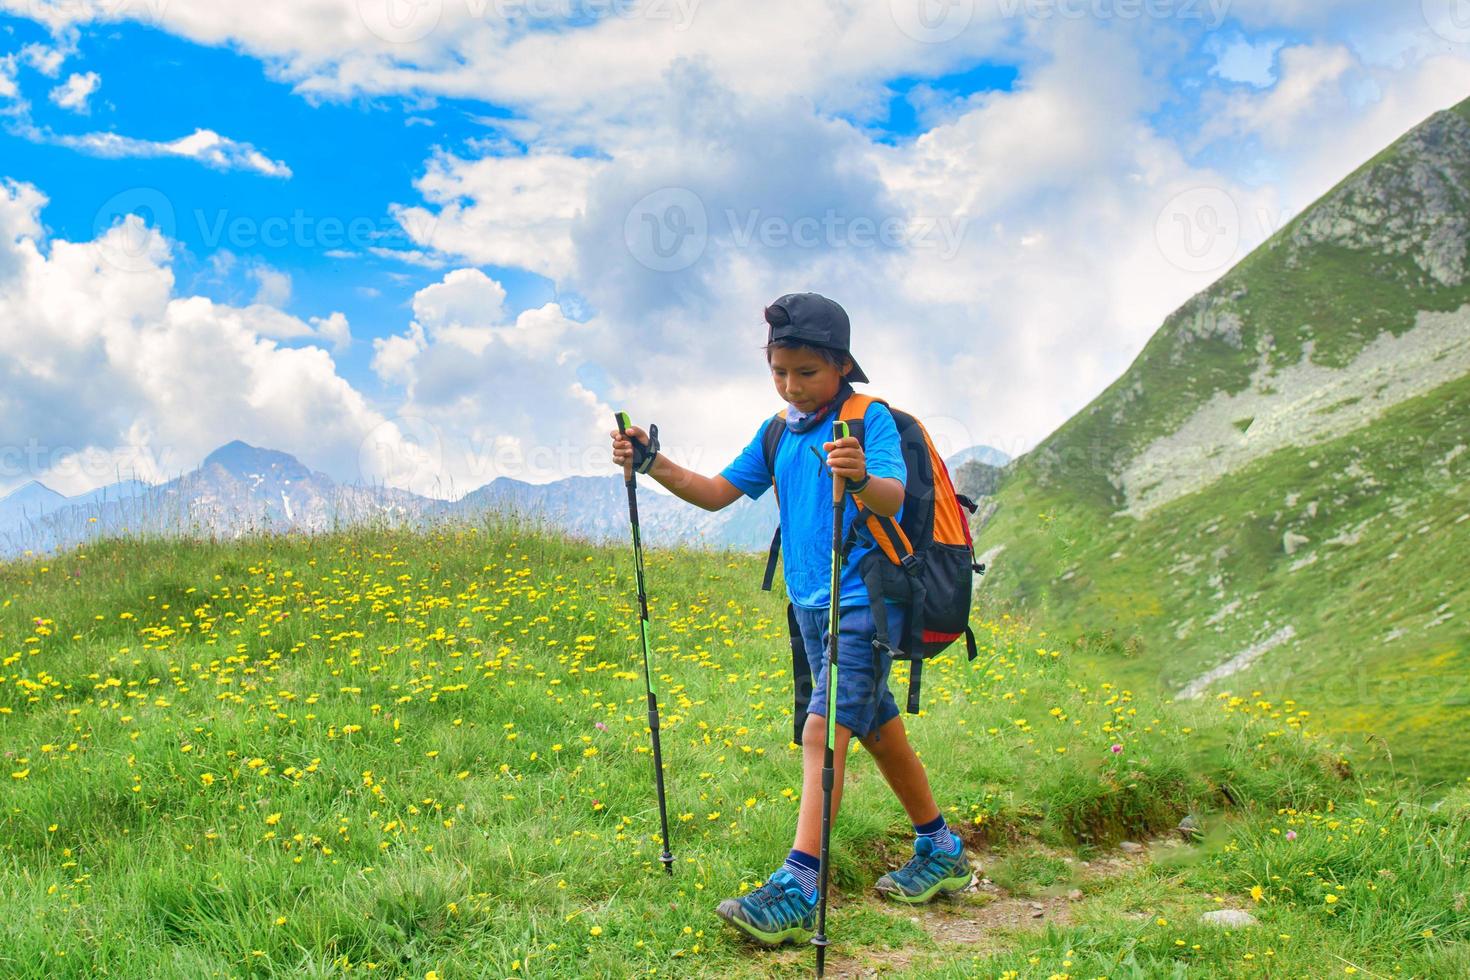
[0,523,1470,979]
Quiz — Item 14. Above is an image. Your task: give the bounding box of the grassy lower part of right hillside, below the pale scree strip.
[979,367,1470,782]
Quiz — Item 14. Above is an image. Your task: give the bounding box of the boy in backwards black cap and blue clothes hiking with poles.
[612,292,972,945]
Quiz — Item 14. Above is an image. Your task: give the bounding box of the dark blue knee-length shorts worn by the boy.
[792,602,908,739]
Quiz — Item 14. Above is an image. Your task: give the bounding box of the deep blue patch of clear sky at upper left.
[0,11,567,398]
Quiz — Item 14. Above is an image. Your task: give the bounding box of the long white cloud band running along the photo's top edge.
[0,0,1016,147]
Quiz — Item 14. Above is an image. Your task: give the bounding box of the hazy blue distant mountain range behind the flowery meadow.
[0,441,1004,558]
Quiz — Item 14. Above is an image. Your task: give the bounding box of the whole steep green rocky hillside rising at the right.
[978,101,1470,779]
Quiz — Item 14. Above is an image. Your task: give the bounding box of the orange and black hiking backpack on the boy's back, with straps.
[760,392,985,743]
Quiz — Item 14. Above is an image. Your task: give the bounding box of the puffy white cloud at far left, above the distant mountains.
[0,181,384,492]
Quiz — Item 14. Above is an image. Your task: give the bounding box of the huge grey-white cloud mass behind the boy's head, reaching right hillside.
[376,11,1466,472]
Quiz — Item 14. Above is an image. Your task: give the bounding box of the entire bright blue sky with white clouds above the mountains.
[0,0,1470,492]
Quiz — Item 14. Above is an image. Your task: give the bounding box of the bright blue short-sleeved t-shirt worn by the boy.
[720,401,908,608]
